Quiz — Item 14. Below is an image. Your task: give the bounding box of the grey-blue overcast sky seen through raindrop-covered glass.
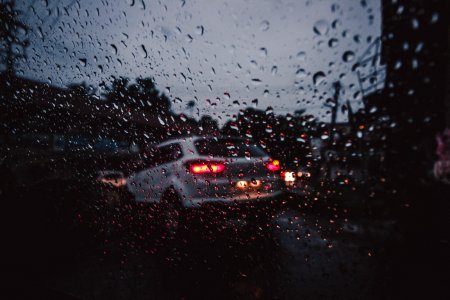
[17,0,381,123]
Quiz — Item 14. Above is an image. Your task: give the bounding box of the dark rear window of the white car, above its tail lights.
[195,139,267,157]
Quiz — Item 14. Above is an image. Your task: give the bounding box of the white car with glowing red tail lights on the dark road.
[127,137,282,232]
